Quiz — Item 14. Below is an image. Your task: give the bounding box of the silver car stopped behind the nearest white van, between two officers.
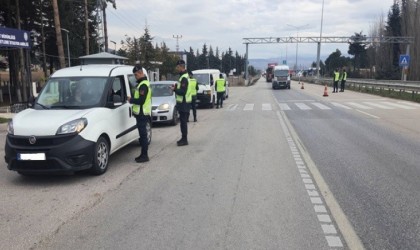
[150,81,179,125]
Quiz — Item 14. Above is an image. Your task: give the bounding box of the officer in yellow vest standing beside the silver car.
[171,60,192,146]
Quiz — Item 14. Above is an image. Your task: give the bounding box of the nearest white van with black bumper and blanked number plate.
[5,64,152,175]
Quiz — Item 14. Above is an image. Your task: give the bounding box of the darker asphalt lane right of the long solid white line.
[272,79,420,249]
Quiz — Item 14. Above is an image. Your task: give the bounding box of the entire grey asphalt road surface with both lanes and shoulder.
[0,79,420,249]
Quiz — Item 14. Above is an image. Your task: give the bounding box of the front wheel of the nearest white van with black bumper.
[90,136,109,175]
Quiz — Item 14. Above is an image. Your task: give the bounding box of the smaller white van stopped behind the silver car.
[192,69,220,108]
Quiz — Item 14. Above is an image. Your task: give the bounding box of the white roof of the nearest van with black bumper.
[51,64,134,77]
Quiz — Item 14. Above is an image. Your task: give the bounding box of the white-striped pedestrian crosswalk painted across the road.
[224,101,420,111]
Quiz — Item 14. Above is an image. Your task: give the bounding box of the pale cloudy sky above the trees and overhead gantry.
[107,0,394,66]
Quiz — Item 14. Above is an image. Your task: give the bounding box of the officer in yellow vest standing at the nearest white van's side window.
[128,64,152,163]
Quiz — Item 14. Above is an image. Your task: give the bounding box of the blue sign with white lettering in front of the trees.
[0,27,31,49]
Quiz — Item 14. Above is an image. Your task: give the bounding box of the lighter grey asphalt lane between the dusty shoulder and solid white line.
[28,81,346,249]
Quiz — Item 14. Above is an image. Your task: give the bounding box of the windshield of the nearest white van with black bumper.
[35,77,108,109]
